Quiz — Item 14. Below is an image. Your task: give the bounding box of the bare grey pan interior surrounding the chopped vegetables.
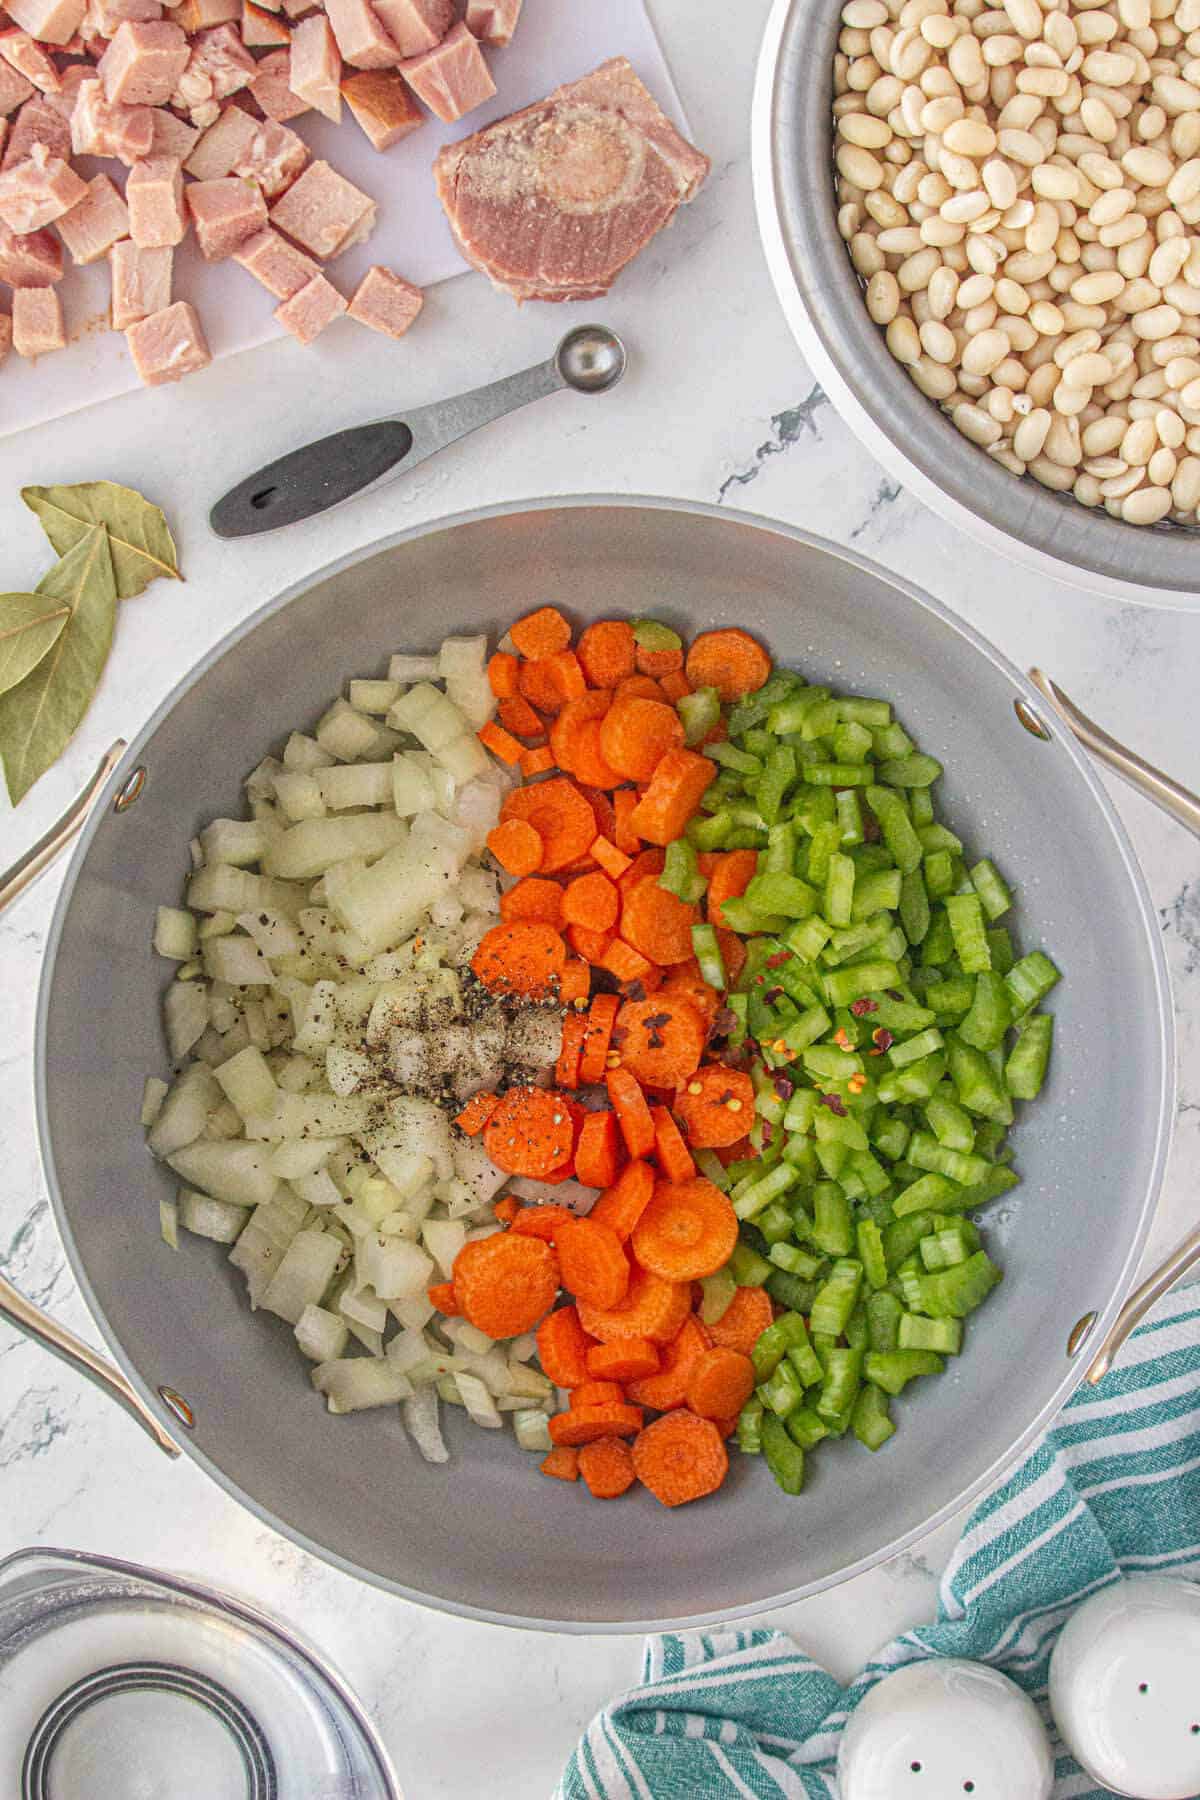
[40,502,1169,1629]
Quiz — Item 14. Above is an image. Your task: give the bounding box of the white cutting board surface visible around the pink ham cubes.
[0,0,687,436]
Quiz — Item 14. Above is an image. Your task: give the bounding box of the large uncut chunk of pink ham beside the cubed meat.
[434,56,709,301]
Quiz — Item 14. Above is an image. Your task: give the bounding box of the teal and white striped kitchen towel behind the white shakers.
[558,1285,1200,1800]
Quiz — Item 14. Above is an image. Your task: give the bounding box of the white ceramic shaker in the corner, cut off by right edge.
[1051,1575,1200,1800]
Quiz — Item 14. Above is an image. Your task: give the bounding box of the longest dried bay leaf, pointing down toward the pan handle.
[0,526,117,806]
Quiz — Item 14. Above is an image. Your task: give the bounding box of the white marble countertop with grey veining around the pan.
[0,0,1200,1800]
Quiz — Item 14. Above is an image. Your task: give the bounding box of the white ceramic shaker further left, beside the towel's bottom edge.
[838,1656,1054,1800]
